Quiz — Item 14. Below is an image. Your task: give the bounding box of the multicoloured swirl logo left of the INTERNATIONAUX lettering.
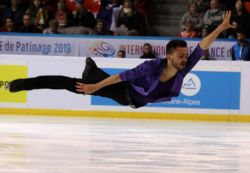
[90,41,115,57]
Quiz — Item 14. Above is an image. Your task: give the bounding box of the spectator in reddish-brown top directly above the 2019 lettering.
[55,0,70,28]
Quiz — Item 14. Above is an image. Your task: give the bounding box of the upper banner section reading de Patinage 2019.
[0,35,79,56]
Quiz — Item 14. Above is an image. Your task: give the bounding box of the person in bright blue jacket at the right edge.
[232,30,250,61]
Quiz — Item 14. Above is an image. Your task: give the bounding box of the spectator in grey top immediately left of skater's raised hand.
[203,0,223,30]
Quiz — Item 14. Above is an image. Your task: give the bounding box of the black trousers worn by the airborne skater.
[25,67,133,105]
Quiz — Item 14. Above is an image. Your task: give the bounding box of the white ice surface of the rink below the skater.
[0,115,250,173]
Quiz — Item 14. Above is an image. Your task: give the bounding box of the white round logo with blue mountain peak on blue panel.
[181,73,201,96]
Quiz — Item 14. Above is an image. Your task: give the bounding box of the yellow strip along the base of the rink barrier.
[0,108,240,122]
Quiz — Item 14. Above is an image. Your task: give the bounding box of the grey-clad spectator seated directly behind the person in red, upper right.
[180,2,203,31]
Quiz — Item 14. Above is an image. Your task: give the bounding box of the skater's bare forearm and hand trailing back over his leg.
[76,74,122,94]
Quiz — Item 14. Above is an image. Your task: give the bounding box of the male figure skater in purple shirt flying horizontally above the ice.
[9,11,234,108]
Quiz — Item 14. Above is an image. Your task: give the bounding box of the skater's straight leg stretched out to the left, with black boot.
[9,76,129,105]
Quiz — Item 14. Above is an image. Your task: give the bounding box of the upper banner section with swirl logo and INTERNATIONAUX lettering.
[79,38,235,60]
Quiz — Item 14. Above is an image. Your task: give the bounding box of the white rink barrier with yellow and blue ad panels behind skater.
[0,54,250,122]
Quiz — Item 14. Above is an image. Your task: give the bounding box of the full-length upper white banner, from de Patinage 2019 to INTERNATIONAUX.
[0,34,236,60]
